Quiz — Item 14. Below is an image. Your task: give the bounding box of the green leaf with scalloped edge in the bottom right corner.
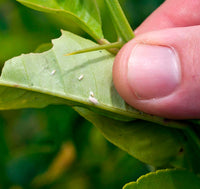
[123,169,200,189]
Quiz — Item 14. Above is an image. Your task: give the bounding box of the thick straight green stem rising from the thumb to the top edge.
[105,0,135,42]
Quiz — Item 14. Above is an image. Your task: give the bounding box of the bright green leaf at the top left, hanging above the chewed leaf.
[17,0,103,41]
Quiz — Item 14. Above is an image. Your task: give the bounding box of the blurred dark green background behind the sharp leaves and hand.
[0,0,163,189]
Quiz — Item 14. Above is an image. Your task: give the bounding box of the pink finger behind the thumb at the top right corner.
[135,0,200,35]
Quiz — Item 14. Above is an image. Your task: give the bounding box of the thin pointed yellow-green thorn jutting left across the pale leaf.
[65,41,124,56]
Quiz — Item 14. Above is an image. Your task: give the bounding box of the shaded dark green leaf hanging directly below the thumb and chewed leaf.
[74,107,183,166]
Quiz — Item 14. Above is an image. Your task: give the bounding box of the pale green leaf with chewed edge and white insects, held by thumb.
[0,31,187,127]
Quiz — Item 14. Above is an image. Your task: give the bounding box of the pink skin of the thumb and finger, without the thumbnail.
[113,0,200,119]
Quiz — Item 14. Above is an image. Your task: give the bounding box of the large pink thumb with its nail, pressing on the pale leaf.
[113,26,200,119]
